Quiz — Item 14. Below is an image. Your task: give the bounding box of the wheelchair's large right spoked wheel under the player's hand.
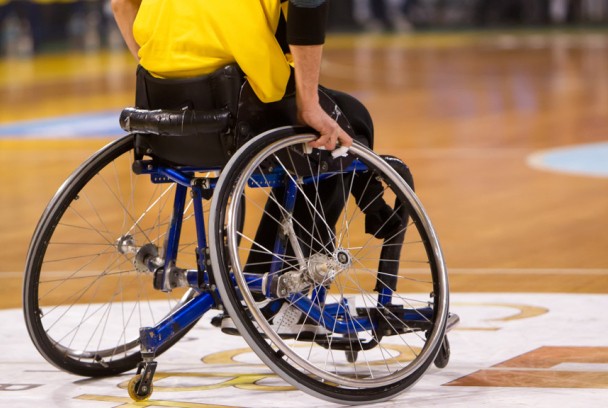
[210,127,448,404]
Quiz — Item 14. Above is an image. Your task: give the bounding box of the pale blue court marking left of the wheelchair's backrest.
[0,111,125,139]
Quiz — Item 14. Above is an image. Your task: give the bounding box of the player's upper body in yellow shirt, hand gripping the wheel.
[112,0,354,150]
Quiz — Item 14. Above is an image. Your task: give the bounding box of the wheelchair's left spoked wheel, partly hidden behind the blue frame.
[23,135,196,376]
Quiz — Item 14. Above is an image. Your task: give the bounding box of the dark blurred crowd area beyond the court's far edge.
[0,0,608,57]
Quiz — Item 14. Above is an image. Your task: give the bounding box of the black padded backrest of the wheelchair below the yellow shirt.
[133,64,244,168]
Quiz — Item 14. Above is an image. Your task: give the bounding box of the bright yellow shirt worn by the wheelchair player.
[133,0,290,102]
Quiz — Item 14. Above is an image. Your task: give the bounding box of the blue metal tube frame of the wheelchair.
[134,160,433,362]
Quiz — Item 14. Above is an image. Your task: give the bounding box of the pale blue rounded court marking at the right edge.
[527,142,608,178]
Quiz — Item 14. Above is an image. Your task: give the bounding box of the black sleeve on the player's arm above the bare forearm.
[287,0,329,45]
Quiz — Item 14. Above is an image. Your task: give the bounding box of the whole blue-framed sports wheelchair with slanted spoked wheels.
[23,65,458,405]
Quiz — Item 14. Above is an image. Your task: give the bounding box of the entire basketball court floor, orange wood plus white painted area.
[0,30,608,408]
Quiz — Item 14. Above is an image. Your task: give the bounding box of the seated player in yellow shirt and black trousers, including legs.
[112,0,410,329]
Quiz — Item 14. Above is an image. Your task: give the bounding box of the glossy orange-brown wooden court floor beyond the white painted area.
[0,31,608,307]
